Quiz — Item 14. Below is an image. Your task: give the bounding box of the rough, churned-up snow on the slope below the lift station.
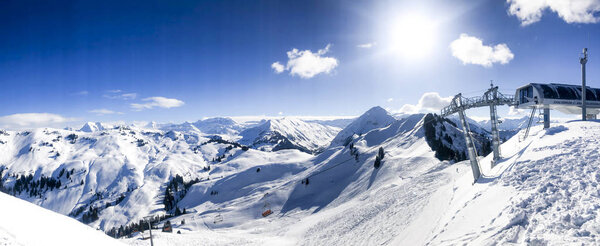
[494,128,600,244]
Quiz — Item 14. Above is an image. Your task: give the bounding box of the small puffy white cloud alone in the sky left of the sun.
[271,44,338,79]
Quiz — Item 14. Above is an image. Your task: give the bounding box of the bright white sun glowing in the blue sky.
[389,14,436,58]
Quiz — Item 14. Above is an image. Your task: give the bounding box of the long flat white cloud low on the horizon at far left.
[0,113,77,130]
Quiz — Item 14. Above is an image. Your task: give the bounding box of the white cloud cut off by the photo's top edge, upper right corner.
[506,0,600,26]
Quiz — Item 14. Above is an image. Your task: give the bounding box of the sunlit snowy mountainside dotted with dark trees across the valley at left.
[0,120,311,235]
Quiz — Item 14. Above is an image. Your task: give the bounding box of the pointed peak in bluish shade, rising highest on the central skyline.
[331,106,396,147]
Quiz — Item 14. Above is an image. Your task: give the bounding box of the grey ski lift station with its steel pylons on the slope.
[440,48,600,181]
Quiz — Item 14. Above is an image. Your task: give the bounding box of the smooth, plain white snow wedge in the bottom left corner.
[0,192,124,246]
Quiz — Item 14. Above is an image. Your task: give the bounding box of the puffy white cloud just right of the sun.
[450,33,515,67]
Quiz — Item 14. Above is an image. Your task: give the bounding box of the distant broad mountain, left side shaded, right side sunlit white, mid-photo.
[239,118,340,153]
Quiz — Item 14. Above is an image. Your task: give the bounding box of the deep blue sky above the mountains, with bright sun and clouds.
[0,0,600,127]
